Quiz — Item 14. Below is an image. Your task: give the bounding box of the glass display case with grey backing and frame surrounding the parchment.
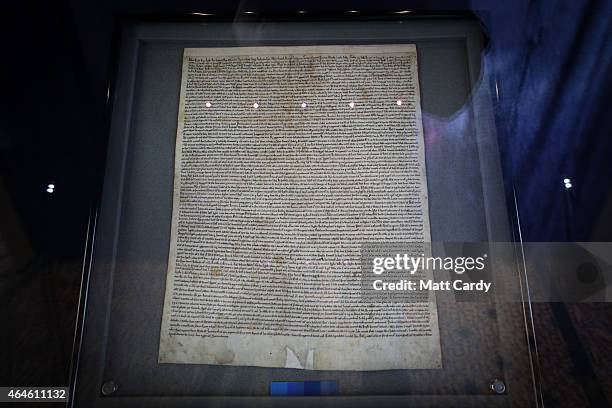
[72,12,541,407]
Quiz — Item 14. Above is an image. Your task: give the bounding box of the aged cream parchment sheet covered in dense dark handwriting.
[159,44,441,370]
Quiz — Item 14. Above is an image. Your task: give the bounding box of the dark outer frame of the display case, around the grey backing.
[70,14,540,407]
